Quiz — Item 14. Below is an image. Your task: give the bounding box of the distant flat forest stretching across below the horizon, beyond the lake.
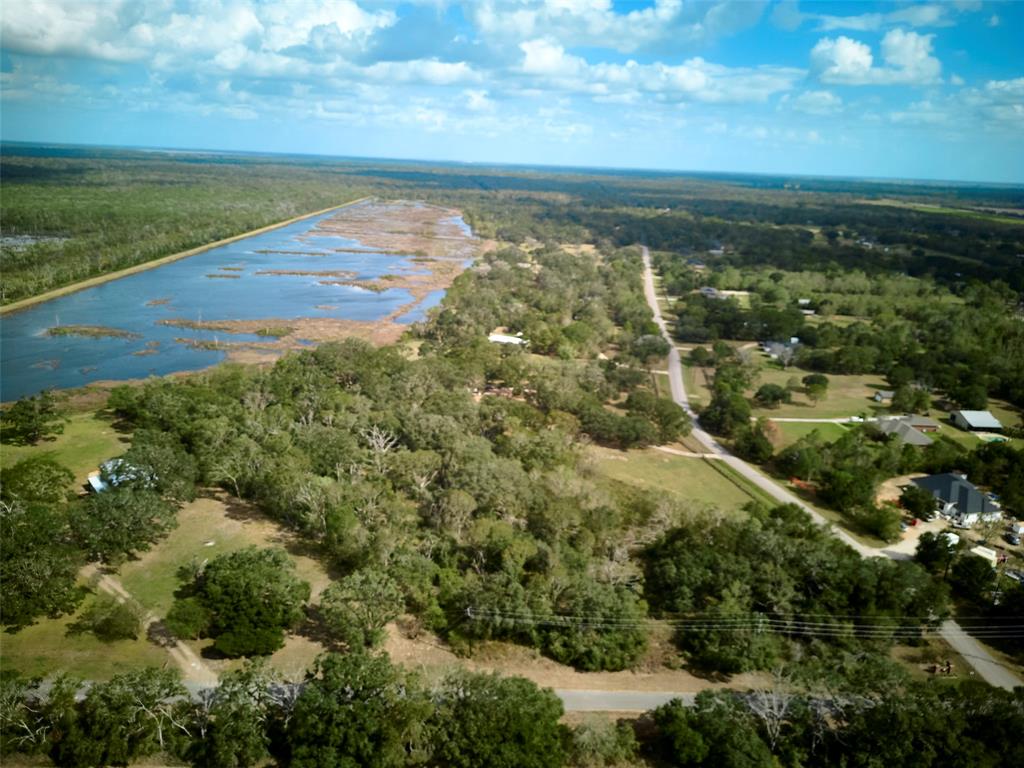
[6,143,1024,303]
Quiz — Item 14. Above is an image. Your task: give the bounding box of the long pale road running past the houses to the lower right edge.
[642,246,1022,690]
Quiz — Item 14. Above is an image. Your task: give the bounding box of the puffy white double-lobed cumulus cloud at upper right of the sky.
[811,29,942,85]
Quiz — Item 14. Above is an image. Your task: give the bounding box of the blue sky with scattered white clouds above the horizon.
[0,0,1024,182]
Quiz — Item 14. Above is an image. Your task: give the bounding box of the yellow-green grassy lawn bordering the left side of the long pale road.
[588,445,761,510]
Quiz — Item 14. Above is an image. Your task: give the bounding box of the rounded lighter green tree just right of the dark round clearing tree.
[319,568,406,649]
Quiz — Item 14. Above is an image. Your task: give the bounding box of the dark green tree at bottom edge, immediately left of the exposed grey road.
[430,671,568,768]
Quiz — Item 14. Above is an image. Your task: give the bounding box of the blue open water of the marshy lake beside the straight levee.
[0,213,468,401]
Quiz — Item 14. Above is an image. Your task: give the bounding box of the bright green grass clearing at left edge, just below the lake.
[0,413,128,487]
